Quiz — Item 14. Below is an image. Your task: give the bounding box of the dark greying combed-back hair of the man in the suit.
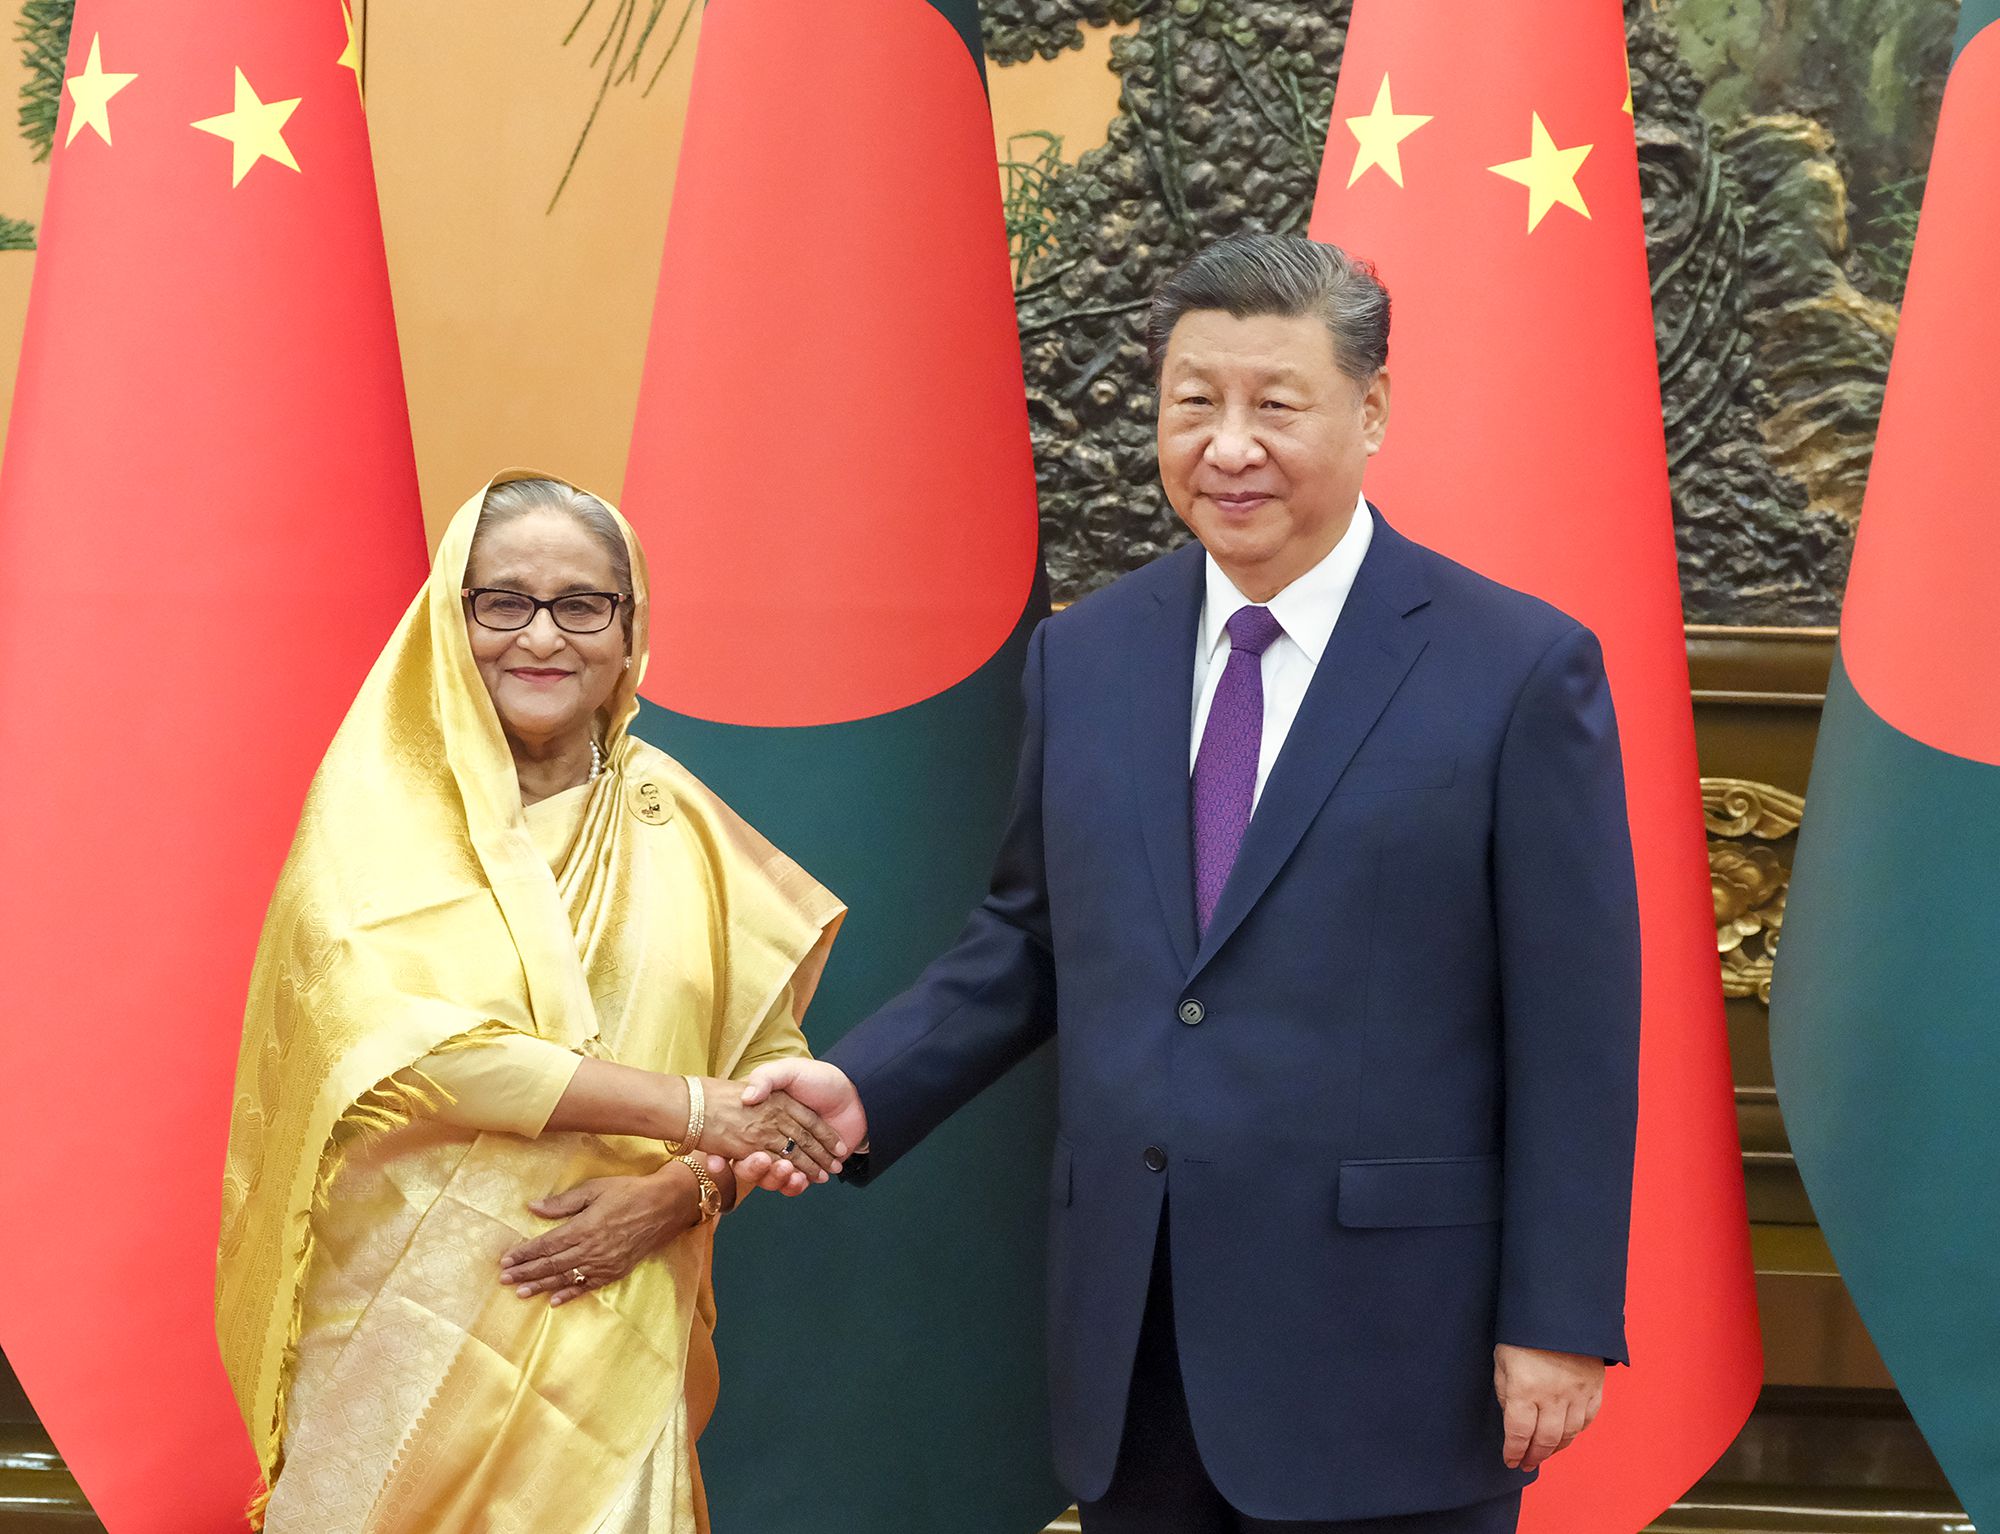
[1146,234,1388,384]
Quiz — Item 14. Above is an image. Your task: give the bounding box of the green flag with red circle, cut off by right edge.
[1770,0,2000,1528]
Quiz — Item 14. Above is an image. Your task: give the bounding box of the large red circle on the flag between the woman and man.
[624,0,1036,726]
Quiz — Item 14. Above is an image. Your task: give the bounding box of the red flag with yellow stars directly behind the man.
[1312,0,1762,1534]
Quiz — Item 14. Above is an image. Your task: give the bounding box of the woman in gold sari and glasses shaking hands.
[216,476,848,1534]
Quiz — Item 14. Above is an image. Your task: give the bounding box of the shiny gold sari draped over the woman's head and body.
[216,474,842,1534]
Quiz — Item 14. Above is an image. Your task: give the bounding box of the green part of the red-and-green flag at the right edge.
[1770,664,2000,1528]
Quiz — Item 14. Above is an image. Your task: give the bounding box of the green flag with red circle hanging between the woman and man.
[624,0,1066,1534]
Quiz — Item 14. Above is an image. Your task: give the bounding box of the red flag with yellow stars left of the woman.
[0,0,424,1534]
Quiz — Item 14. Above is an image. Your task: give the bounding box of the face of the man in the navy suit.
[1160,310,1388,602]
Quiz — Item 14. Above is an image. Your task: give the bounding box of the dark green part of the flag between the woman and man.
[638,592,1068,1534]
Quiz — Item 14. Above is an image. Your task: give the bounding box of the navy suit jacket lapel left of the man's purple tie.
[1130,544,1204,968]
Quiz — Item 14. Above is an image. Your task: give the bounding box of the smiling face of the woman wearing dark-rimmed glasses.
[466,510,626,750]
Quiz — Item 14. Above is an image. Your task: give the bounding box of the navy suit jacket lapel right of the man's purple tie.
[1182,512,1428,978]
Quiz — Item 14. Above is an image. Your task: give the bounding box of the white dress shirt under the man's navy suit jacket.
[1188,498,1374,810]
